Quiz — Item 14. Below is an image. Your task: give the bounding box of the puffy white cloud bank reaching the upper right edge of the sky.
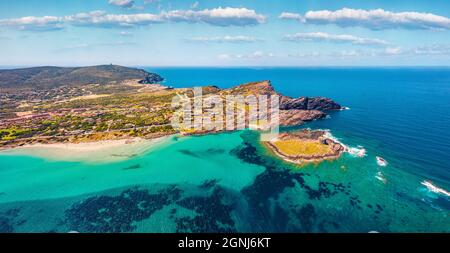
[280,8,450,30]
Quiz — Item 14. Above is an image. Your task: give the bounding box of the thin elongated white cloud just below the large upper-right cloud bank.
[284,32,389,46]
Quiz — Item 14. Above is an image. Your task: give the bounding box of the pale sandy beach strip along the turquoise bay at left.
[0,136,172,163]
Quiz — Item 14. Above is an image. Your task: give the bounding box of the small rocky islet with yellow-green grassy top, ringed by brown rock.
[264,129,345,165]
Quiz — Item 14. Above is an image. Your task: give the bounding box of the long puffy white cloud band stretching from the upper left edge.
[0,7,266,30]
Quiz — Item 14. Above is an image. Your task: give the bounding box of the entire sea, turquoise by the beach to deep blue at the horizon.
[0,68,450,232]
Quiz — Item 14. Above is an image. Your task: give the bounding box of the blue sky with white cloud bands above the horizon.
[0,0,450,66]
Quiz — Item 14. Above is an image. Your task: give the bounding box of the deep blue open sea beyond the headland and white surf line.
[146,67,450,186]
